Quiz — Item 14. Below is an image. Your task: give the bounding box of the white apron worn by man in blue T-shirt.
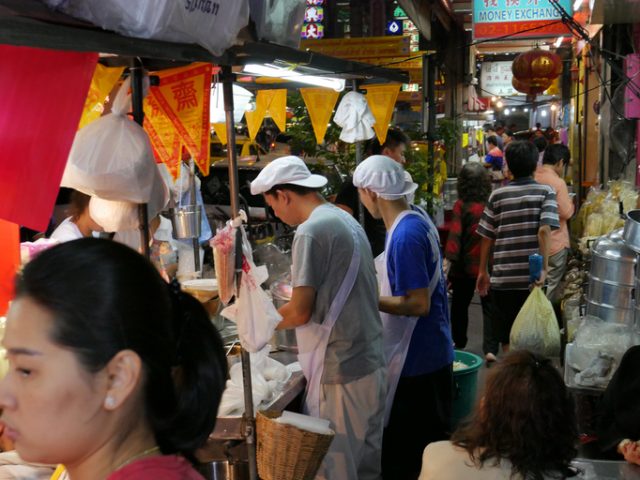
[375,207,442,427]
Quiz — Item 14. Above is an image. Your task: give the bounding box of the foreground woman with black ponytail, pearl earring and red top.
[0,238,226,480]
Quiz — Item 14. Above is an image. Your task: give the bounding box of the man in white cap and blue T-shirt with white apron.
[353,155,453,480]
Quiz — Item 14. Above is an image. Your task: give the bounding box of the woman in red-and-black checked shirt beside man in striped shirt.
[445,162,498,361]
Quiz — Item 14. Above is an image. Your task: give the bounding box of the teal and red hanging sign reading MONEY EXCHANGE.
[473,0,573,39]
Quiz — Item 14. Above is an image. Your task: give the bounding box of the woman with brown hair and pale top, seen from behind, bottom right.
[419,350,578,480]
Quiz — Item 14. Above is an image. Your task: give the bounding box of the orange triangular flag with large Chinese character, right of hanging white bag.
[149,63,212,175]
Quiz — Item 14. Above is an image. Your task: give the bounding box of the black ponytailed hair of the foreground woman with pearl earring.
[16,238,227,460]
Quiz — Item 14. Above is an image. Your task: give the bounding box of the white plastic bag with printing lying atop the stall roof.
[43,0,249,55]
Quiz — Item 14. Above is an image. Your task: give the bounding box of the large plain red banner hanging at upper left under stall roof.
[0,45,98,230]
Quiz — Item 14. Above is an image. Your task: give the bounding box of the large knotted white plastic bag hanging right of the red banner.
[61,79,157,203]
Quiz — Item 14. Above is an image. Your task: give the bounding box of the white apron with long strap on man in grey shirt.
[296,211,360,417]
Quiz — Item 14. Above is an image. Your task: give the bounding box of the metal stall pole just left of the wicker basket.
[220,66,258,480]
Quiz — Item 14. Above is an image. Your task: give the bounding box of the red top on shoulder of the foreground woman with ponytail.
[107,455,202,480]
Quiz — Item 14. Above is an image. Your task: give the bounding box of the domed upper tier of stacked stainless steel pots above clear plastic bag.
[590,237,637,286]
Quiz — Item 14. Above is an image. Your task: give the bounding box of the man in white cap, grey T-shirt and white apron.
[251,156,387,480]
